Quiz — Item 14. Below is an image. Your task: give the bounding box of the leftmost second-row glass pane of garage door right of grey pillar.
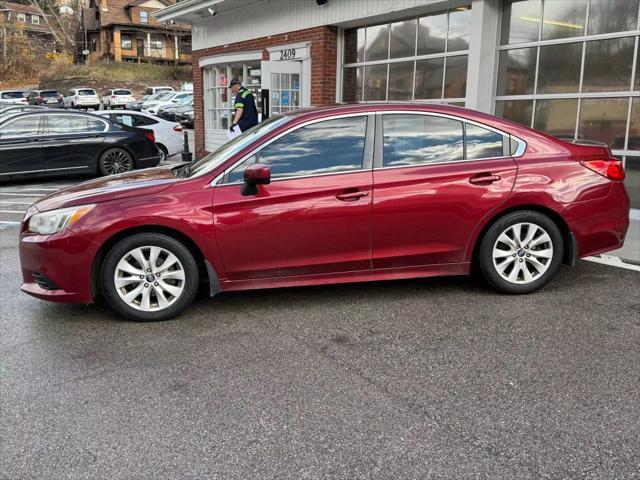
[498,48,536,95]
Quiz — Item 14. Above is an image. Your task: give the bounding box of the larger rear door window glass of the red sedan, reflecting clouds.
[383,114,464,167]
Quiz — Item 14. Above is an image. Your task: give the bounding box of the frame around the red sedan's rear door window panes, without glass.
[373,110,527,171]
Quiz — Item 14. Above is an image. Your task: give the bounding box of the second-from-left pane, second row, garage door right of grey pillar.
[538,43,582,93]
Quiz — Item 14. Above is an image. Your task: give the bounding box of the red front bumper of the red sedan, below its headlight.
[19,228,100,303]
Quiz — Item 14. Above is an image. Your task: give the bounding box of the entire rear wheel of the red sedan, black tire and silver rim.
[477,210,564,294]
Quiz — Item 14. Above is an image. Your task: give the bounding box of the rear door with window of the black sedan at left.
[41,113,109,173]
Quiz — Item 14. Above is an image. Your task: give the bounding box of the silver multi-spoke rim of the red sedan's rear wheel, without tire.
[492,222,553,285]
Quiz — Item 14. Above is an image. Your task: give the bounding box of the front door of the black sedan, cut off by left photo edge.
[0,114,43,176]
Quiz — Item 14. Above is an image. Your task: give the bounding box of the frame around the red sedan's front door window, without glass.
[216,112,377,187]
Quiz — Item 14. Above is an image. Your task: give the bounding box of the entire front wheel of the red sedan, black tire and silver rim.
[100,233,199,322]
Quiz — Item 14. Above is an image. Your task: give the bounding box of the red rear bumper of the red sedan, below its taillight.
[561,182,630,258]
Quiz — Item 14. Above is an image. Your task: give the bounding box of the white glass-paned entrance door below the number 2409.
[260,60,304,116]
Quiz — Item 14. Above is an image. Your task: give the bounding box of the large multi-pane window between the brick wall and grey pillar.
[342,6,471,103]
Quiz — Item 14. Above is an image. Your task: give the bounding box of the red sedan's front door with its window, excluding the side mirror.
[213,115,373,280]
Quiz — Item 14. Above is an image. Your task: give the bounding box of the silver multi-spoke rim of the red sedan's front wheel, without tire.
[113,246,186,312]
